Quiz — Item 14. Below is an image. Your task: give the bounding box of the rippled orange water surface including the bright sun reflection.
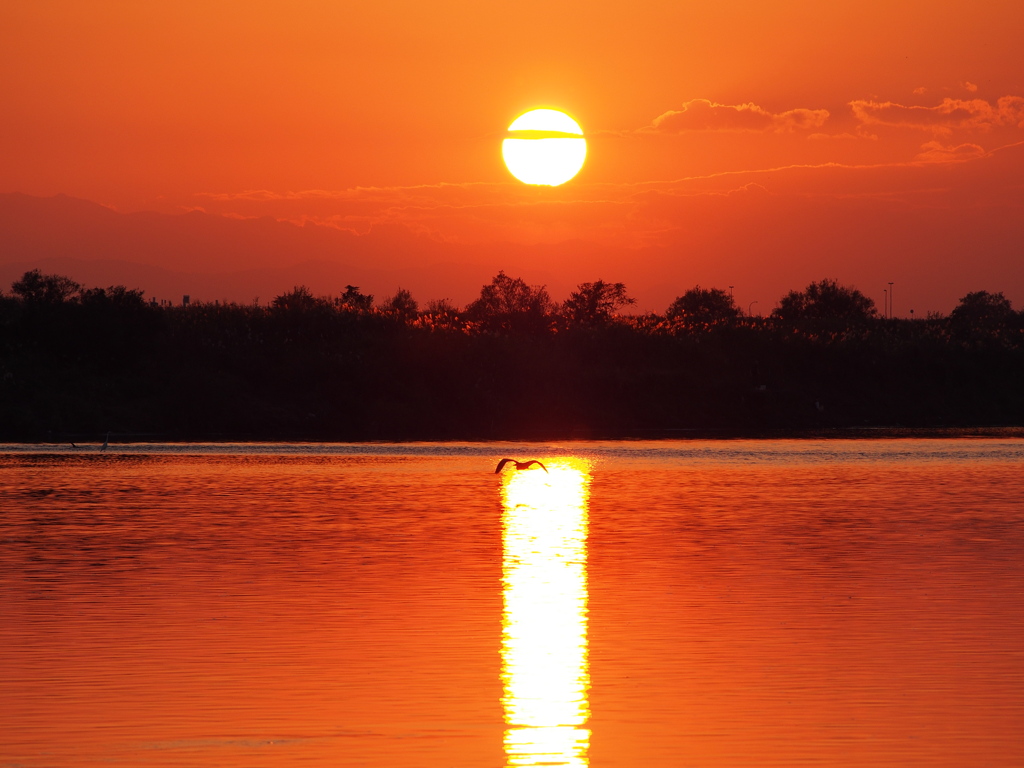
[0,439,1024,768]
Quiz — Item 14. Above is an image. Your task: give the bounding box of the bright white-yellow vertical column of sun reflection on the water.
[502,459,590,767]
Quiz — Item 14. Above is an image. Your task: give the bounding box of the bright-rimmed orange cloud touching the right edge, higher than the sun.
[850,96,1024,133]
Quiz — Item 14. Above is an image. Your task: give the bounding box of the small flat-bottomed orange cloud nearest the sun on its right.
[643,98,828,133]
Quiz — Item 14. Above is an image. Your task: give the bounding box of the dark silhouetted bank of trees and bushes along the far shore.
[0,270,1024,441]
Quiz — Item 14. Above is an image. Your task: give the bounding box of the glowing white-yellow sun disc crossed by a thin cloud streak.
[502,110,587,186]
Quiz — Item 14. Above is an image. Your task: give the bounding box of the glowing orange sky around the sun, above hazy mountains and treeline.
[0,0,1024,313]
